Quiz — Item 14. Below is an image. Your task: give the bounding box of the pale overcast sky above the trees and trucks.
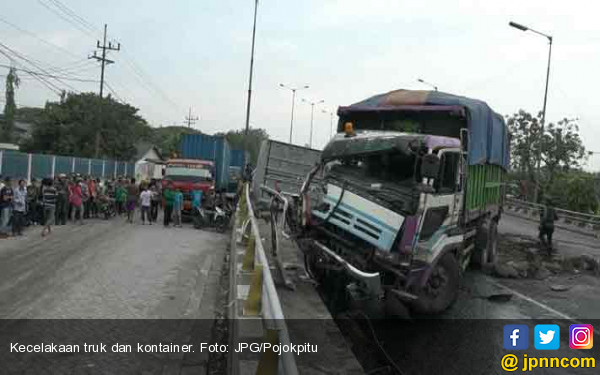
[0,0,600,170]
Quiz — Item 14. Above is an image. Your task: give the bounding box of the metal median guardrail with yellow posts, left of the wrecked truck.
[229,184,298,375]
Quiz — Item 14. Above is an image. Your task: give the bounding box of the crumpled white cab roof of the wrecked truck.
[321,131,460,161]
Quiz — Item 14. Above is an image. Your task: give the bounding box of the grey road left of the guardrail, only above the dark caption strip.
[0,218,227,319]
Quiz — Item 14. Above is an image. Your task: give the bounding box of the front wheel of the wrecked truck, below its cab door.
[412,253,460,314]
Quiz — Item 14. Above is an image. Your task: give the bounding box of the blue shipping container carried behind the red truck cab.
[179,134,231,189]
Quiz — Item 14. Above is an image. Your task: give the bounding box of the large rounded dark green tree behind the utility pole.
[26,93,153,160]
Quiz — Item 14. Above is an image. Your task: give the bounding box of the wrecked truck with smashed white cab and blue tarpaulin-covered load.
[270,90,509,314]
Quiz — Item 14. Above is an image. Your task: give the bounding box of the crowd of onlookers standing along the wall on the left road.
[0,174,201,238]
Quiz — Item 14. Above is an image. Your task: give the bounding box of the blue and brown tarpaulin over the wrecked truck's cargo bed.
[338,90,509,169]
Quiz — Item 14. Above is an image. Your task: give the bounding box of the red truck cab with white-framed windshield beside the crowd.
[162,159,215,213]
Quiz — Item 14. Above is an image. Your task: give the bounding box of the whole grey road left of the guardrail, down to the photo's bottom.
[0,218,227,374]
